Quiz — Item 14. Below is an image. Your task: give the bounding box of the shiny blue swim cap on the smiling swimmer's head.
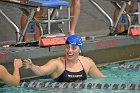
[66,35,83,49]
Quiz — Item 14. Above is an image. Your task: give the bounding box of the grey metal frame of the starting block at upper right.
[89,0,140,35]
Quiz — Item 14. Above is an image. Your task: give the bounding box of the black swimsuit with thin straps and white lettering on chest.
[54,61,87,82]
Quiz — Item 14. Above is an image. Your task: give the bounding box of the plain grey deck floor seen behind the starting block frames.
[0,0,114,42]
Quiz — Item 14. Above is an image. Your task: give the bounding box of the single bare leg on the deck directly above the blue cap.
[70,0,80,35]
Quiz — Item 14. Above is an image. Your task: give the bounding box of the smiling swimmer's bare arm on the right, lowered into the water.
[88,59,107,78]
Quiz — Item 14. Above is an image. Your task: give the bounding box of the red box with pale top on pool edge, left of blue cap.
[39,34,67,47]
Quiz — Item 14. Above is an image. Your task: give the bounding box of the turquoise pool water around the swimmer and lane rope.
[0,60,140,93]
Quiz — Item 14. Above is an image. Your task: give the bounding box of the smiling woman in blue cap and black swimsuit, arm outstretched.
[23,35,107,82]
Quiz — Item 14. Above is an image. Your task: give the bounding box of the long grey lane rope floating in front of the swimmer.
[19,82,140,90]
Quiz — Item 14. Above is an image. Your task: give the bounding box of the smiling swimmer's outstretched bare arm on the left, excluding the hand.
[24,59,57,76]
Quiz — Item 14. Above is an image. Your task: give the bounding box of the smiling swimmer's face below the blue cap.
[65,44,80,60]
